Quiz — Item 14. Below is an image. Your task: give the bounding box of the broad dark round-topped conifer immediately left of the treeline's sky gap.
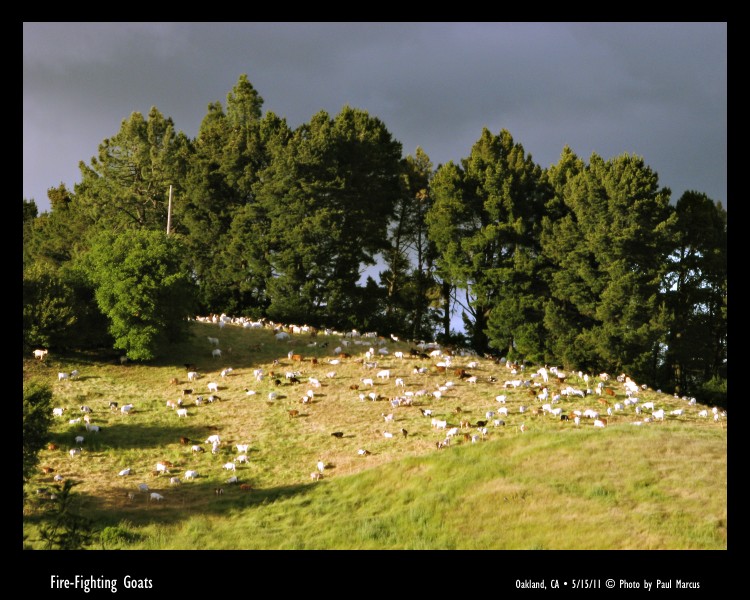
[253,107,401,327]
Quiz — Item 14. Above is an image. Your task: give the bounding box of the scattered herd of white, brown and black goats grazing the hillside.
[29,315,726,506]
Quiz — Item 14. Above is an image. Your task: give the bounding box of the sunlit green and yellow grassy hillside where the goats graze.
[24,323,727,549]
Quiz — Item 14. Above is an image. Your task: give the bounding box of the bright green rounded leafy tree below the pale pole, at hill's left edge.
[81,230,195,360]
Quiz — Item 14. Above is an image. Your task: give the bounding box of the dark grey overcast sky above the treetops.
[23,22,727,216]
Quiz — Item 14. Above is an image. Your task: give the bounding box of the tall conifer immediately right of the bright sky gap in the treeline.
[427,129,546,358]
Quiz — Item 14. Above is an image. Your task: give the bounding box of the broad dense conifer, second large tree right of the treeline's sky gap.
[542,151,675,381]
